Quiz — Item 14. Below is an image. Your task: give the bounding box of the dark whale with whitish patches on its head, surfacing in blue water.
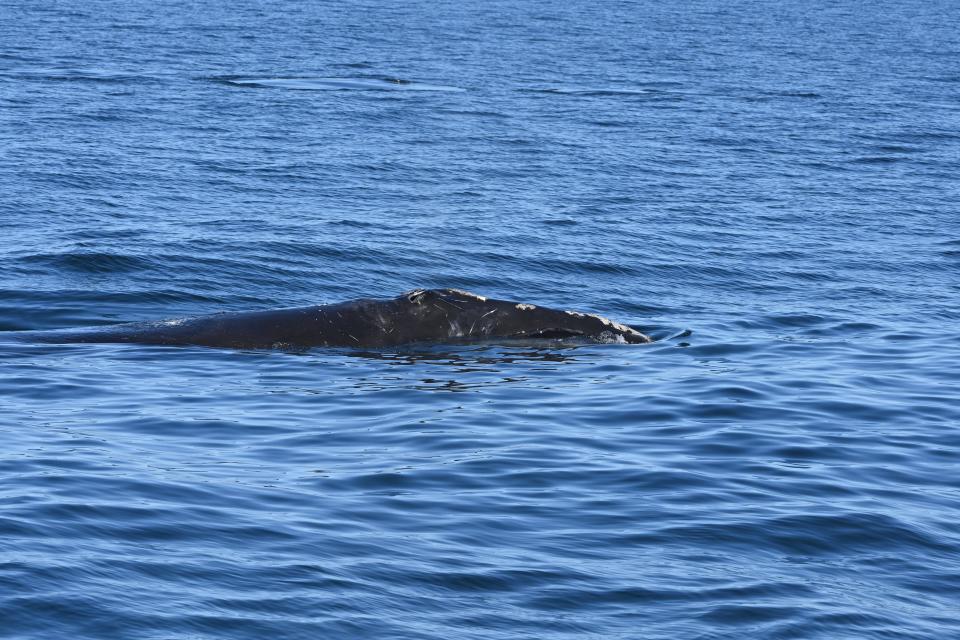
[24,289,651,349]
